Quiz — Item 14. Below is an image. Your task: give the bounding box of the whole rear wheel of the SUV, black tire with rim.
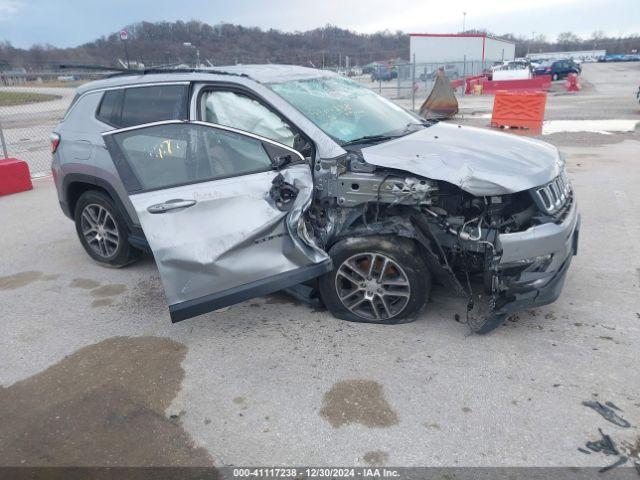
[74,190,142,268]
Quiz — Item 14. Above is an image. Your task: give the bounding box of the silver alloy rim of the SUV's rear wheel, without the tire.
[81,203,120,258]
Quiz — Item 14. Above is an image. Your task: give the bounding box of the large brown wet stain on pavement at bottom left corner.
[0,337,212,466]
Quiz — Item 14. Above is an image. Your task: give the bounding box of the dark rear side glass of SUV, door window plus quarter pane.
[96,85,188,127]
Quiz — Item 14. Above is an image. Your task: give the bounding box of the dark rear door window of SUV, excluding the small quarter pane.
[119,85,188,127]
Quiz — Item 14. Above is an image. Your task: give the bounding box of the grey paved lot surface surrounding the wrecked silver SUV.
[0,64,640,466]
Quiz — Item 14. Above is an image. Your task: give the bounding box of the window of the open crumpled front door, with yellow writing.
[114,123,271,190]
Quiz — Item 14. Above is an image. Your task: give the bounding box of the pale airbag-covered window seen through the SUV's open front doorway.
[200,91,295,147]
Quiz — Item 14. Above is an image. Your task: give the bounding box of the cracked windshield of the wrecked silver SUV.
[269,77,424,144]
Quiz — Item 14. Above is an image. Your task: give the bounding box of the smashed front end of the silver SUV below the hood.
[306,146,580,333]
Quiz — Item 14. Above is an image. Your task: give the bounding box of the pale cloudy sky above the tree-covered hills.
[0,0,640,48]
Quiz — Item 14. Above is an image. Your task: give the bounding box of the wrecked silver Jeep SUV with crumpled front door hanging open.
[51,65,580,333]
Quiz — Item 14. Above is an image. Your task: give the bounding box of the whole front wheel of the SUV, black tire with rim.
[319,236,431,325]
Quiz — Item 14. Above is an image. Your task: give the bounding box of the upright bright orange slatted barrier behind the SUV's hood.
[491,91,547,129]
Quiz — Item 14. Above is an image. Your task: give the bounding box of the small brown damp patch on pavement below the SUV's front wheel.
[320,380,398,428]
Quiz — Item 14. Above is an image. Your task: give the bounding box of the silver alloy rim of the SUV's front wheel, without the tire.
[335,252,411,321]
